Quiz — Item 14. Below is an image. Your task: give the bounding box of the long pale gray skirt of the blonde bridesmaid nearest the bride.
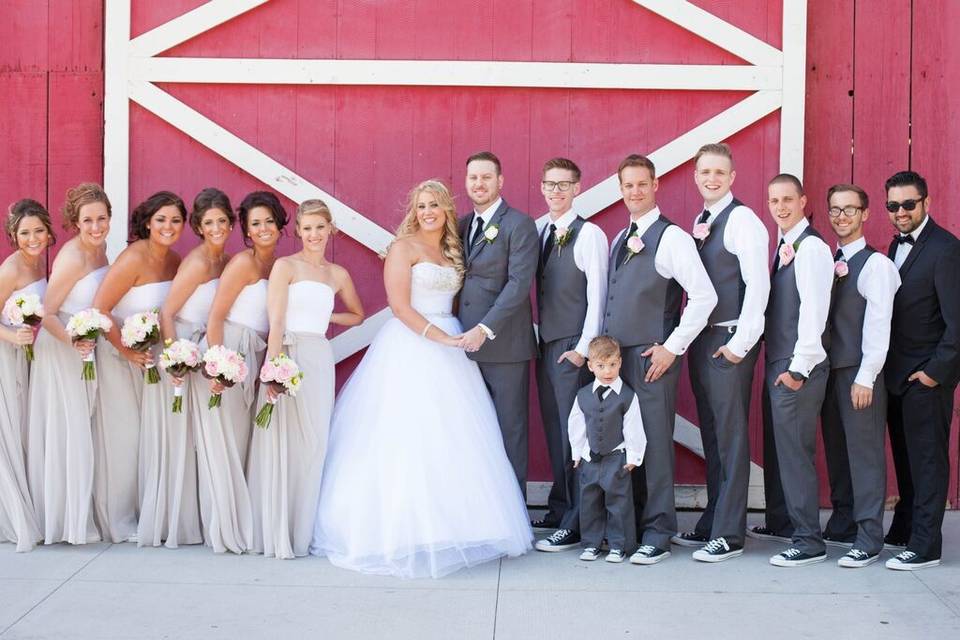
[247,332,334,559]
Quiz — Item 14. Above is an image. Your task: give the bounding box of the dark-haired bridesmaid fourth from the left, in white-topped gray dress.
[137,188,236,549]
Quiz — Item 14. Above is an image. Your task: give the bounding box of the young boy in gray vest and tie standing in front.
[568,336,647,562]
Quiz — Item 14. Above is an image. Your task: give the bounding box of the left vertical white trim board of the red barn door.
[103,0,130,260]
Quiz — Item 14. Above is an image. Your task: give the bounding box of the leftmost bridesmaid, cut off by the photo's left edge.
[0,200,56,551]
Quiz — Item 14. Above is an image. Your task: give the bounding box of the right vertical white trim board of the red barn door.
[780,0,807,180]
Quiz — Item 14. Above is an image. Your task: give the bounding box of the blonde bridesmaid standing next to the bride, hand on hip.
[249,200,363,558]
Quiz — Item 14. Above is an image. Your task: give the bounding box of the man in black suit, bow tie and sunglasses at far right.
[884,171,960,570]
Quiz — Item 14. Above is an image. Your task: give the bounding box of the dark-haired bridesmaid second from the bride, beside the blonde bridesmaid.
[194,191,287,553]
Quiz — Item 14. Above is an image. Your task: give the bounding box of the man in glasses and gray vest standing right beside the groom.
[532,158,608,551]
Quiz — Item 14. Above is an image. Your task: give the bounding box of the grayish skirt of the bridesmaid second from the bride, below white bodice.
[190,321,267,553]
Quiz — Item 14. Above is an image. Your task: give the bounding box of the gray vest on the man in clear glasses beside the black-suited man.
[828,245,876,369]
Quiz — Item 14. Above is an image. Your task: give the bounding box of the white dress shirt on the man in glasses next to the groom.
[537,209,609,358]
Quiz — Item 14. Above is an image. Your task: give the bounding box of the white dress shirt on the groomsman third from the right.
[777,218,833,376]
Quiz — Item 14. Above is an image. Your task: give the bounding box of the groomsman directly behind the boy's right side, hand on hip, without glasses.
[602,155,717,564]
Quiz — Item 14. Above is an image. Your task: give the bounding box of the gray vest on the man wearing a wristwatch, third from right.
[763,227,829,362]
